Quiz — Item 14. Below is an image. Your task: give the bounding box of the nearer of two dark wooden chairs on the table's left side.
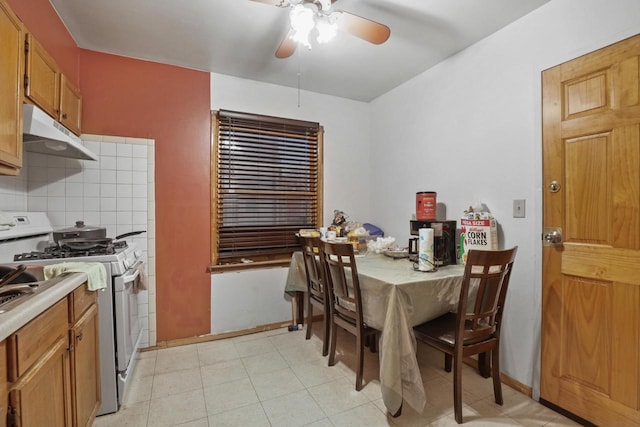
[322,242,380,391]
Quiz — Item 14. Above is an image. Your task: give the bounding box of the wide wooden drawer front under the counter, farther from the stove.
[7,298,69,381]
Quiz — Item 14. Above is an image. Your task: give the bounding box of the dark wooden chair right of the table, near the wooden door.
[413,247,518,424]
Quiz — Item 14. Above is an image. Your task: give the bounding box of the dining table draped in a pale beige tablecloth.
[285,251,464,415]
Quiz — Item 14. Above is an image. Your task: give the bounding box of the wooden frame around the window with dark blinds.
[209,110,324,273]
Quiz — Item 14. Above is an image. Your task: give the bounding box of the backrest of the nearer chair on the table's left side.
[322,242,363,326]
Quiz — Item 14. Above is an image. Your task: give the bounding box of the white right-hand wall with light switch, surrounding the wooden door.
[371,0,640,395]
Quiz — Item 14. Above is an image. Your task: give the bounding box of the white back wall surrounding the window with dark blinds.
[211,74,374,334]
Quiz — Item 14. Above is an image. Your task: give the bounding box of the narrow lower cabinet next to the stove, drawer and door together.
[70,285,100,427]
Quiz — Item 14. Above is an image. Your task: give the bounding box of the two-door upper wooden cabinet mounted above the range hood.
[24,34,82,135]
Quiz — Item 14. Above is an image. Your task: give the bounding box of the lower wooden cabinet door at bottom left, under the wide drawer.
[9,335,71,427]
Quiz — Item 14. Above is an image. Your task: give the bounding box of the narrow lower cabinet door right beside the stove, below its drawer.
[71,304,100,427]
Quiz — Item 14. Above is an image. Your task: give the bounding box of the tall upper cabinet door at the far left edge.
[0,0,24,175]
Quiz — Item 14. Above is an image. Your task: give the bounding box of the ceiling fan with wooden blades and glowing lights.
[253,0,391,58]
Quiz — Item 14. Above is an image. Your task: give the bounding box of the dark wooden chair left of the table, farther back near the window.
[300,236,331,356]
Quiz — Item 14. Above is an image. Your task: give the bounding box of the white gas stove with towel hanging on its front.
[0,212,144,415]
